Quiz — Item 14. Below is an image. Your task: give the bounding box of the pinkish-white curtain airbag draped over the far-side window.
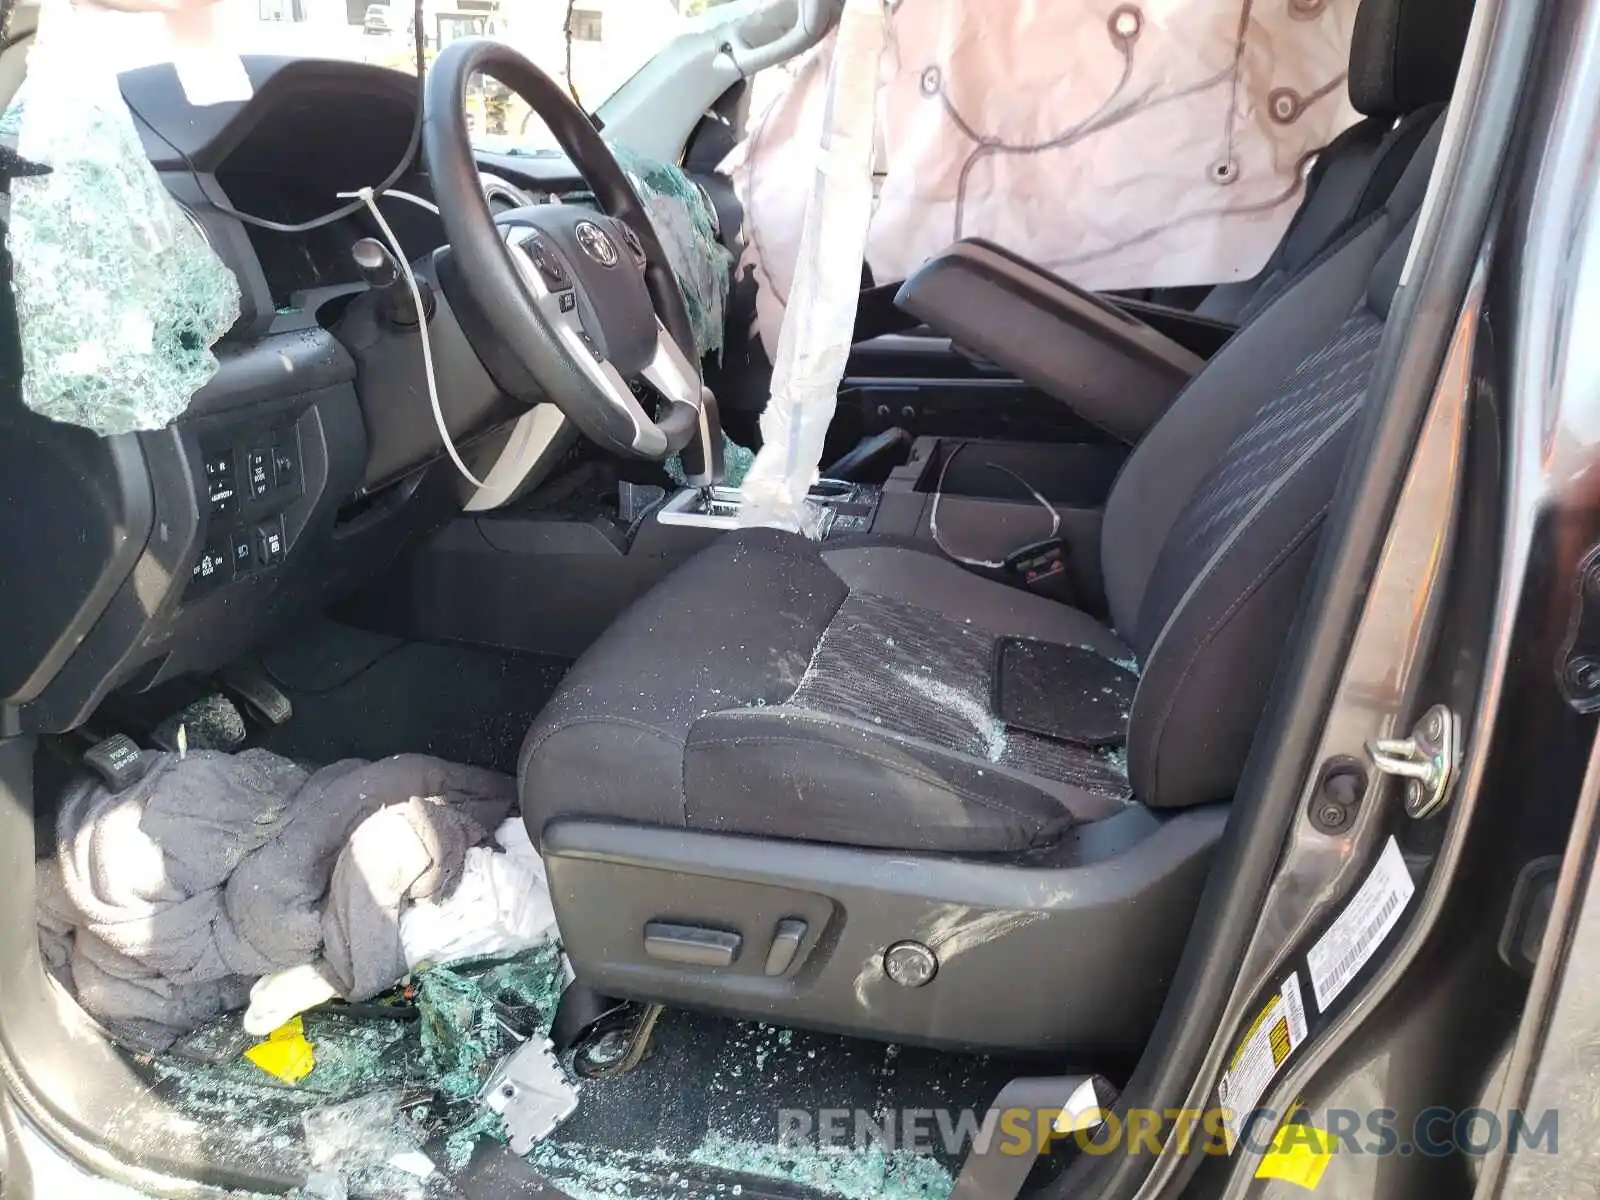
[725,0,1357,350]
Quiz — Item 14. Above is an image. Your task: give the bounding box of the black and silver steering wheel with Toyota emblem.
[422,37,709,461]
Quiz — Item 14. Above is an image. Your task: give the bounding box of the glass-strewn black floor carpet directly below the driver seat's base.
[528,1010,1038,1200]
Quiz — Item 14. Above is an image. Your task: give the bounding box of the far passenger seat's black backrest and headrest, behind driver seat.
[1195,0,1472,325]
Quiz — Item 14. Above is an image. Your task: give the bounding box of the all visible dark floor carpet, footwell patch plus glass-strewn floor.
[106,622,1081,1200]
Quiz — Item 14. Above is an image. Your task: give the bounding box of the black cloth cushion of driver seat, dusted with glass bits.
[522,530,1131,853]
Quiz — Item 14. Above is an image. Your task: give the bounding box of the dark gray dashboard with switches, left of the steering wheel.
[0,58,604,733]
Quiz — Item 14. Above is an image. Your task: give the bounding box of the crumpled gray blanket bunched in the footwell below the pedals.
[37,750,515,1050]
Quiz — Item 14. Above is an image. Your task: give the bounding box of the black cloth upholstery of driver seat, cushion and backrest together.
[520,115,1438,856]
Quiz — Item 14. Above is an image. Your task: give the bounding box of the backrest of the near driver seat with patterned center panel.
[1101,118,1443,806]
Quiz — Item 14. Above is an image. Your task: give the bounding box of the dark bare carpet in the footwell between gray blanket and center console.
[256,621,571,773]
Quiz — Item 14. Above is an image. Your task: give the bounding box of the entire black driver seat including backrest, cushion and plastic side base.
[520,125,1440,1051]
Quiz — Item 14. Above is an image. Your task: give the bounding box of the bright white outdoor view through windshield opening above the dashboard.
[90,0,752,150]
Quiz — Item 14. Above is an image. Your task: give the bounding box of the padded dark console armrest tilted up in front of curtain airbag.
[894,238,1205,442]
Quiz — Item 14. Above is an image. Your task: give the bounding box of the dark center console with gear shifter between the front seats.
[350,437,1126,658]
